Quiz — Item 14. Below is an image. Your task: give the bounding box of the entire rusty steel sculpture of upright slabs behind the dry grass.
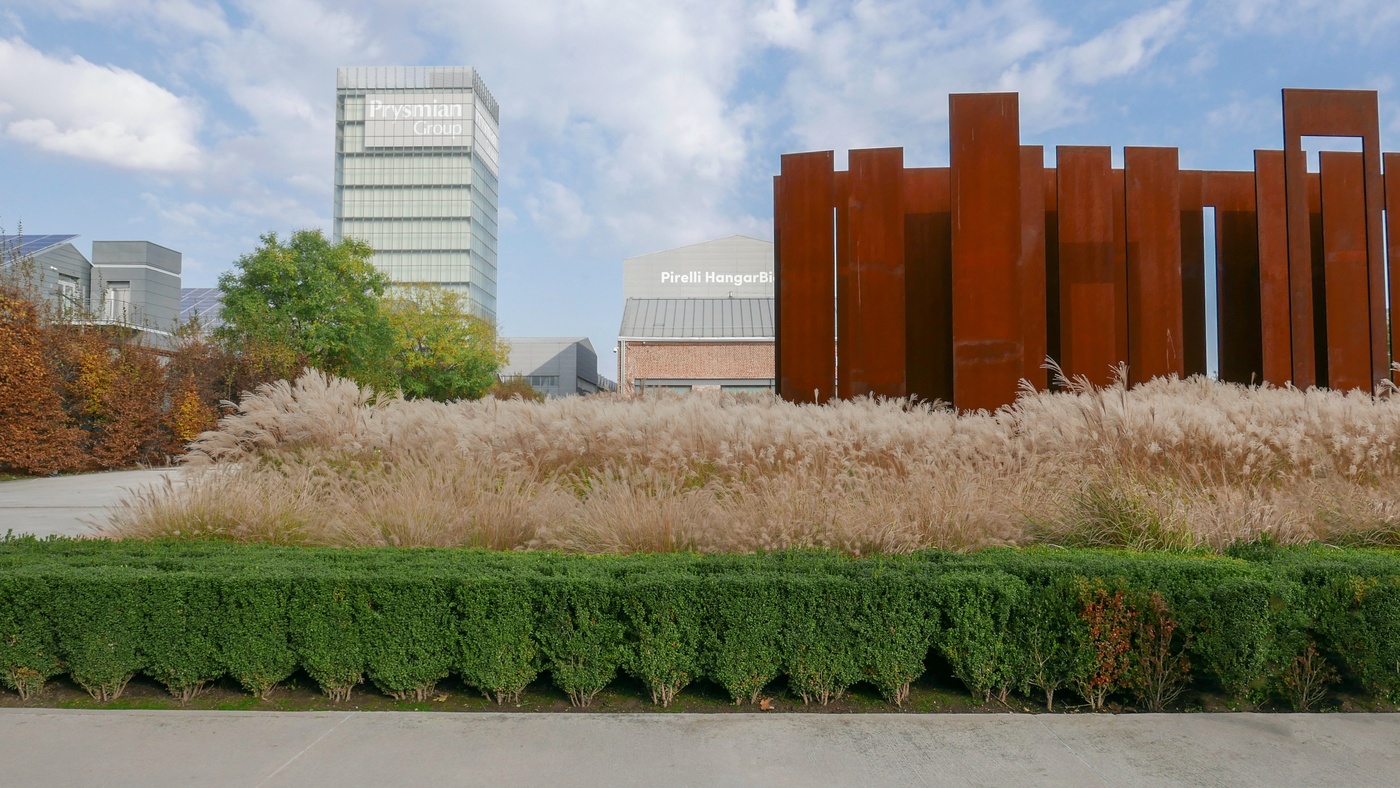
[773,90,1400,409]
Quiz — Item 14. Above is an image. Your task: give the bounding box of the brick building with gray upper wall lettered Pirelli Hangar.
[617,235,774,391]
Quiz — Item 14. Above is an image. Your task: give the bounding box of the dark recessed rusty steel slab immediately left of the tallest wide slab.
[904,167,953,404]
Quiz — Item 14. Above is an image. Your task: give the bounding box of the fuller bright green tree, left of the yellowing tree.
[218,230,393,386]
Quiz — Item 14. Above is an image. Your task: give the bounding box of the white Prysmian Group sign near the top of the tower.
[364,92,472,148]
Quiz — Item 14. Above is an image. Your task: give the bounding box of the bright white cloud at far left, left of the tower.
[0,39,202,172]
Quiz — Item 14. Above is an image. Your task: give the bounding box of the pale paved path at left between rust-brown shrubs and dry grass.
[0,467,181,540]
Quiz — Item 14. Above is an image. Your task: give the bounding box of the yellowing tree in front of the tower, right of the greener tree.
[384,284,510,400]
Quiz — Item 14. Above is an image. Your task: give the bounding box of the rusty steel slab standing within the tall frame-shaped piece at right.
[1319,151,1373,391]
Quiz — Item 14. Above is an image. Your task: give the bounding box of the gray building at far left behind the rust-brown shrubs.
[0,235,182,347]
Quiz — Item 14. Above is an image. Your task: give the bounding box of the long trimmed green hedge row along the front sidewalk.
[0,539,1400,710]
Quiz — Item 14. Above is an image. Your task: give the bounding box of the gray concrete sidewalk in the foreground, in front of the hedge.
[0,710,1400,787]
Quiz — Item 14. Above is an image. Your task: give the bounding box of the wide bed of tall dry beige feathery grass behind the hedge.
[109,372,1400,554]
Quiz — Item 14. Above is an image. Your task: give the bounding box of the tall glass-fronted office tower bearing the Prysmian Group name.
[335,66,500,321]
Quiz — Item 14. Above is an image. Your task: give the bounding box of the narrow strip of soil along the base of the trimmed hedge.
[0,672,1400,714]
